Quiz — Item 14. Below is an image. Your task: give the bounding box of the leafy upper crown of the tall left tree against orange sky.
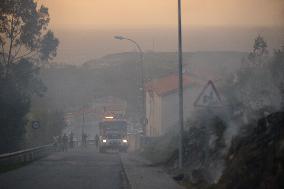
[0,0,59,77]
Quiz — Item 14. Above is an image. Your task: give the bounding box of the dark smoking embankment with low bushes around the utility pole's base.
[142,112,284,189]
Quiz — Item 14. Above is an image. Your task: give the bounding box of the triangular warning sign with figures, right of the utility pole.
[194,80,222,107]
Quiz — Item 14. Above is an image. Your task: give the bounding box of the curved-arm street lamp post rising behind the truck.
[114,36,146,134]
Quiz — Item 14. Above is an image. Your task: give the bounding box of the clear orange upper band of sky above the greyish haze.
[39,0,284,29]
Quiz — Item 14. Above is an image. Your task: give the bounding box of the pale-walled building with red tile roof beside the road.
[145,75,204,137]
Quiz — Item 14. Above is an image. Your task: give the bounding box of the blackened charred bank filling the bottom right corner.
[210,112,284,189]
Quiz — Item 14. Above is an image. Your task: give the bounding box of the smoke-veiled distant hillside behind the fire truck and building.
[34,52,247,118]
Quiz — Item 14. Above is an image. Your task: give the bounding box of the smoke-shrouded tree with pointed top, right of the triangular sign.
[226,36,281,124]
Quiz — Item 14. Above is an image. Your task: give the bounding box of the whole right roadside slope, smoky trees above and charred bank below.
[142,36,284,189]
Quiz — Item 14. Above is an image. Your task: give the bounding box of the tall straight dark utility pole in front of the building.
[178,0,183,169]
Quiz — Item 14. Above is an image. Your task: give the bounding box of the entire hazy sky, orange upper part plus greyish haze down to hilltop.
[37,0,284,64]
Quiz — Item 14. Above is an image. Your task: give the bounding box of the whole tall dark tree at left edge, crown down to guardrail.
[0,0,59,153]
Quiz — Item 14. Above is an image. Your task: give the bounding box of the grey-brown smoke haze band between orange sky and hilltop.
[54,26,284,65]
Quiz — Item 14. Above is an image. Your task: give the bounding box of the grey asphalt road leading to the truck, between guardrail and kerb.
[0,148,125,189]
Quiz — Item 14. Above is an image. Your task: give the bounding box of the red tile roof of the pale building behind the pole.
[145,74,190,96]
